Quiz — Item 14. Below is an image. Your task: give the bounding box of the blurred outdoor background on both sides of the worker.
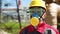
[0,0,60,34]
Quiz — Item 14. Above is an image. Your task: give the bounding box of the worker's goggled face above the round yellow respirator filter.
[30,7,45,18]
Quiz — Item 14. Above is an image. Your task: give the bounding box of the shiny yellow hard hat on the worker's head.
[29,0,46,9]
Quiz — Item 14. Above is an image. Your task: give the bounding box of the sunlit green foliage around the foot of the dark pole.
[0,21,29,34]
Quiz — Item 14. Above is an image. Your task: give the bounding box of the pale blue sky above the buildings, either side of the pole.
[2,0,31,8]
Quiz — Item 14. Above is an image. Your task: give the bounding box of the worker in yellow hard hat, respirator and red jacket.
[20,0,59,34]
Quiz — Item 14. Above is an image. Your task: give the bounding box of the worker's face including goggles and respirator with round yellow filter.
[29,7,45,26]
